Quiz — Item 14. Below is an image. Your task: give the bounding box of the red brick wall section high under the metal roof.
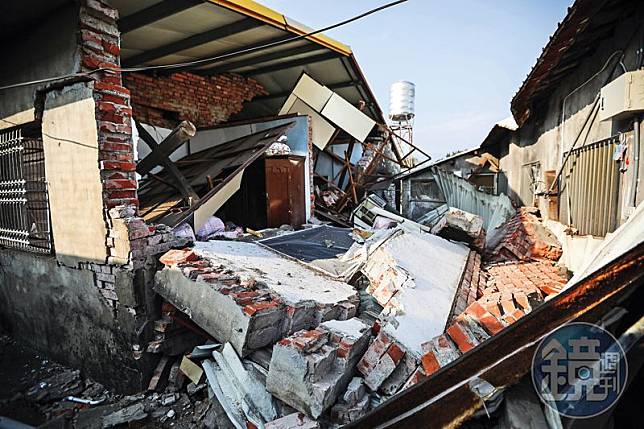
[125,73,266,128]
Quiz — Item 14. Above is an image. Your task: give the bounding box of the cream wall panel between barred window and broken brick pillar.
[42,84,108,266]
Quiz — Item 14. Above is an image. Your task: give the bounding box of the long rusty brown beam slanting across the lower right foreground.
[346,244,644,428]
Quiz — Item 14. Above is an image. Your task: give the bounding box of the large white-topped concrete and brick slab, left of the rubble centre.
[155,241,359,356]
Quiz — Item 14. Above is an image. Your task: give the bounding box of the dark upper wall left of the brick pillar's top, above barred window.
[0,1,79,129]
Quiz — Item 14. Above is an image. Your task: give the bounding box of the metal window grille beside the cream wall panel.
[0,129,53,253]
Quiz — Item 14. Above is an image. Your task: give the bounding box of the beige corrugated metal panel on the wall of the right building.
[559,136,619,237]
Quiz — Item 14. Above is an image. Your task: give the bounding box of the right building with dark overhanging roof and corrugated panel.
[506,0,644,238]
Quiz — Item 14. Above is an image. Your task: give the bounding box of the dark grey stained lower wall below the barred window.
[0,250,143,390]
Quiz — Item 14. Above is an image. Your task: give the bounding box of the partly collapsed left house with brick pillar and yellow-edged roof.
[0,0,384,390]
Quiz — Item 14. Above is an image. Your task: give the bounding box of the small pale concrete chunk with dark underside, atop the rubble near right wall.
[431,207,485,252]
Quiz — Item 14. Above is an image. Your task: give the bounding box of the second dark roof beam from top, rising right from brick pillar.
[123,18,263,67]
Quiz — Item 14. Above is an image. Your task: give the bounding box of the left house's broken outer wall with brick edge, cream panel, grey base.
[0,0,185,391]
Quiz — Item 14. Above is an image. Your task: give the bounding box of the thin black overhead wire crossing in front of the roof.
[0,0,408,91]
